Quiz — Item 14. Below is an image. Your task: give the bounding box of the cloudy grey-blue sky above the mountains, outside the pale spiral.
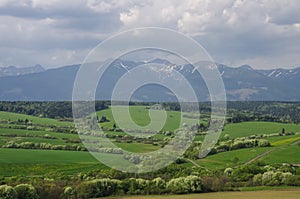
[0,0,300,69]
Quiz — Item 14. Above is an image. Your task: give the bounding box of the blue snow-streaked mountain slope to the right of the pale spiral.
[219,65,300,101]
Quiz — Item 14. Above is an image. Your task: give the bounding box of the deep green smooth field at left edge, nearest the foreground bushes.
[0,149,103,176]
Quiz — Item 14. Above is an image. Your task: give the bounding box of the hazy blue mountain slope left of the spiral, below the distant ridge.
[0,65,79,101]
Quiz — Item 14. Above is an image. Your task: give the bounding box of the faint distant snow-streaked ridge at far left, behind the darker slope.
[0,65,45,77]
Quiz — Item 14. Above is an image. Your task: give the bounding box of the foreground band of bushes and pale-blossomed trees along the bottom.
[0,162,300,199]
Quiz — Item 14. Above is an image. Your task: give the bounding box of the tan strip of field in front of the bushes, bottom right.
[108,189,300,199]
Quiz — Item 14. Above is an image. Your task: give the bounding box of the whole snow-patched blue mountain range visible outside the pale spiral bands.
[0,59,300,101]
